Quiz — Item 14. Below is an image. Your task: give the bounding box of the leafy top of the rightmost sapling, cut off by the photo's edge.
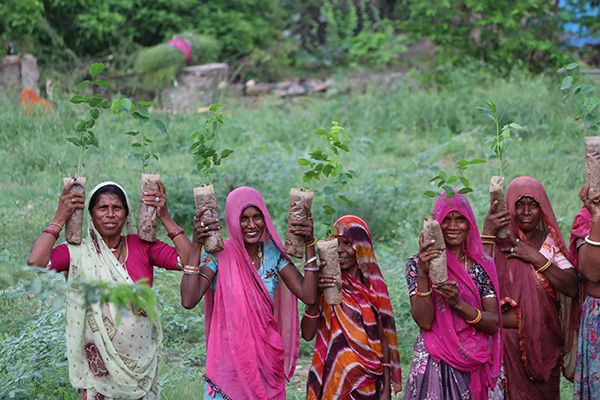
[557,63,600,136]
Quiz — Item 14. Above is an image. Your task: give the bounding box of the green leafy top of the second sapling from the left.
[111,97,168,174]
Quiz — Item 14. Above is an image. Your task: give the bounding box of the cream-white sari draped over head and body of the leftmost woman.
[66,182,162,400]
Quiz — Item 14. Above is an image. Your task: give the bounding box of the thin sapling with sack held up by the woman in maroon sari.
[478,100,523,239]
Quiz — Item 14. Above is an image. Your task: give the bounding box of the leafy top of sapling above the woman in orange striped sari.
[298,121,358,236]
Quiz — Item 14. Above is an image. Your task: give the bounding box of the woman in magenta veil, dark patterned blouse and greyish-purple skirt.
[404,193,502,400]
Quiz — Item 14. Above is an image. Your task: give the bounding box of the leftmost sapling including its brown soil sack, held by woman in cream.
[63,63,110,245]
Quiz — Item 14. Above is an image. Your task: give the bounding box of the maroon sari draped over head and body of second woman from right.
[494,177,576,400]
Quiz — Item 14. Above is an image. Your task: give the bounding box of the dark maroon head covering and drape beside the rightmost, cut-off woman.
[495,176,578,382]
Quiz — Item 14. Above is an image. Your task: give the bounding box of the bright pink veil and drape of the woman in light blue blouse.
[205,187,299,399]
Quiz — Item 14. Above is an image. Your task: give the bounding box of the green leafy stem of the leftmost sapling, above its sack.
[66,63,110,178]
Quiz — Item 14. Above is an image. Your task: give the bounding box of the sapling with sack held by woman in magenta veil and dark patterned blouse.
[422,159,486,287]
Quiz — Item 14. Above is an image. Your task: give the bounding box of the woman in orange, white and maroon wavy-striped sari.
[301,215,402,400]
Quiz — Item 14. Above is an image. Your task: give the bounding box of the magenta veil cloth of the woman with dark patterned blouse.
[423,192,502,400]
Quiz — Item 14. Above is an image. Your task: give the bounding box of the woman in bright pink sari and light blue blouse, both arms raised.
[181,187,318,399]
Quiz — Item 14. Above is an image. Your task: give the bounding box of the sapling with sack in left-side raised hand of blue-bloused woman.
[190,104,233,254]
